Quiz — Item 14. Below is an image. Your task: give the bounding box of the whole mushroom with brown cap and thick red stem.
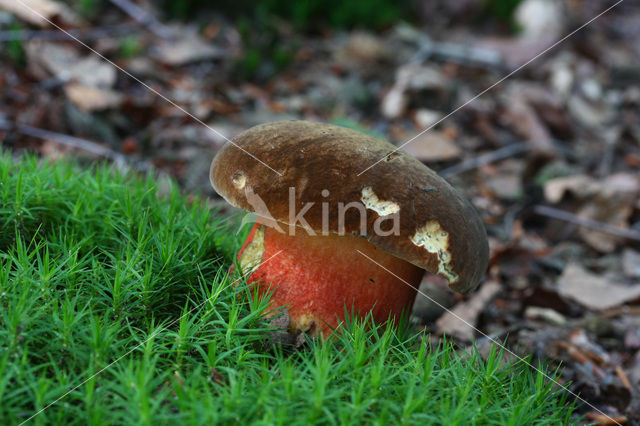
[210,121,489,335]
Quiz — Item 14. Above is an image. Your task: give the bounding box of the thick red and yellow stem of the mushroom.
[238,223,424,336]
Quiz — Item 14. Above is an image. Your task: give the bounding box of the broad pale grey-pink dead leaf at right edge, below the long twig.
[558,263,640,310]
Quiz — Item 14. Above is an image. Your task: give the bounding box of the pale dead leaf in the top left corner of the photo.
[0,0,81,28]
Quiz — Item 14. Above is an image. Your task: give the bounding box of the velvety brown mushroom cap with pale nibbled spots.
[211,121,489,293]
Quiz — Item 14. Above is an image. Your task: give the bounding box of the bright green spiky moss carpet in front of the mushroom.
[0,153,572,425]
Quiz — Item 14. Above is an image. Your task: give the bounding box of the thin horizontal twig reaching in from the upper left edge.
[0,23,140,43]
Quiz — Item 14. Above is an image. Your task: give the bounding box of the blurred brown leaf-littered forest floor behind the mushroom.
[0,0,640,424]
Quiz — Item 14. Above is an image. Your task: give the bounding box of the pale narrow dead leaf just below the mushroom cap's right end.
[436,281,502,342]
